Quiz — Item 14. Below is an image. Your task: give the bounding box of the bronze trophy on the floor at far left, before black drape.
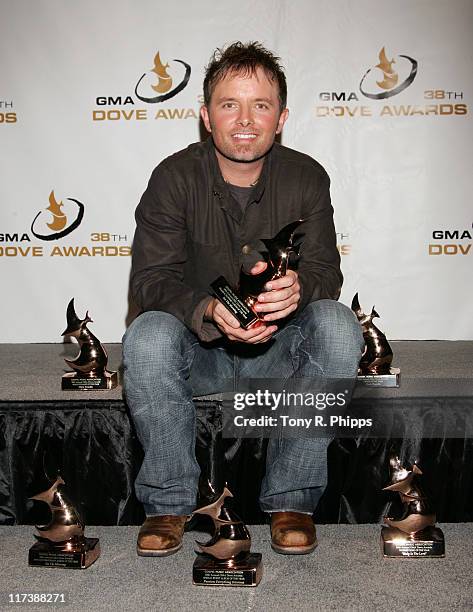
[28,476,100,569]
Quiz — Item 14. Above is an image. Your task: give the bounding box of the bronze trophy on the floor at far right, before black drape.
[381,457,445,558]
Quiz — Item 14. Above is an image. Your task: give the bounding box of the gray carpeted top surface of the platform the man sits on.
[0,341,473,401]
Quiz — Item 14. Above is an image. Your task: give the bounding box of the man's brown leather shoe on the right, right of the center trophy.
[271,512,317,555]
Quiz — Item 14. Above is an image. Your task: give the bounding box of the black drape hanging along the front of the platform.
[0,400,473,525]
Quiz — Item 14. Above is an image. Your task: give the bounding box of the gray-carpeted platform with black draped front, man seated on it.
[0,341,473,525]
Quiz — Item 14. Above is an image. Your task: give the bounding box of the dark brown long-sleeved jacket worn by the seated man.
[131,138,343,341]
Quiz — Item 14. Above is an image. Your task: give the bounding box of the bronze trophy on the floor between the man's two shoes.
[192,487,263,586]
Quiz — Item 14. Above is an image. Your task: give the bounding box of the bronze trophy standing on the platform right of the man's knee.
[351,293,401,387]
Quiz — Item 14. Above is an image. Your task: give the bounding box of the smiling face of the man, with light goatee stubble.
[201,68,288,163]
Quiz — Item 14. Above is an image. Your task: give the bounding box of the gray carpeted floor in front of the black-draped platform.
[0,524,473,612]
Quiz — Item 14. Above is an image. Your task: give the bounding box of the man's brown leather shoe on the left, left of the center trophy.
[136,514,187,557]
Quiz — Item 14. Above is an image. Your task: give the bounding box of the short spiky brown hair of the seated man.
[204,41,287,111]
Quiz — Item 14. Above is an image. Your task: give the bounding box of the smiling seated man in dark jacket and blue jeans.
[124,43,363,556]
